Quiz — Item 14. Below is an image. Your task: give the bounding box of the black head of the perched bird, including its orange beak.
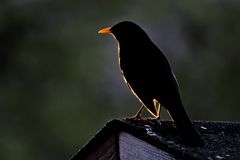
[98,21,149,44]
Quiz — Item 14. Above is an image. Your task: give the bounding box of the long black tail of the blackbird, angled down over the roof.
[168,106,204,146]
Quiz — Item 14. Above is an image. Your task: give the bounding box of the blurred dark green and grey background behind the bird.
[0,0,240,160]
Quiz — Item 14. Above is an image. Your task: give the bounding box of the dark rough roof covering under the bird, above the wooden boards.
[72,119,240,160]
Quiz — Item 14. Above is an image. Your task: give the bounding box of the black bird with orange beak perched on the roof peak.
[98,21,203,146]
